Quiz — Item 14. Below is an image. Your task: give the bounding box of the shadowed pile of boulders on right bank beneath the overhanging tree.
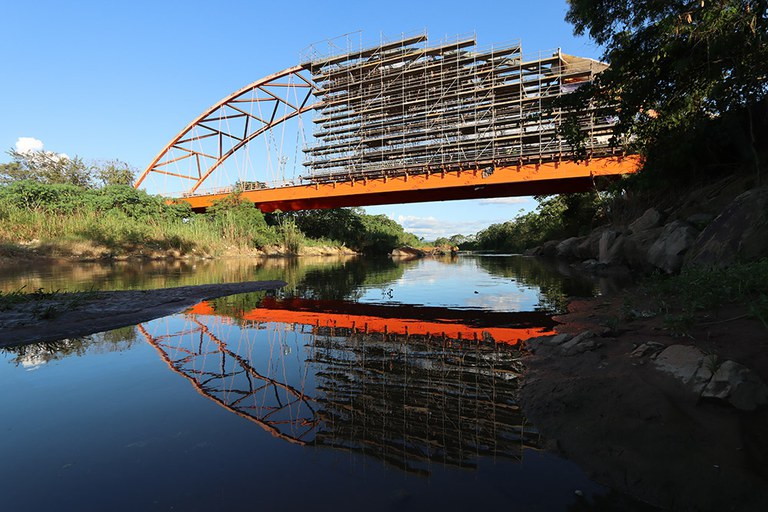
[526,183,768,274]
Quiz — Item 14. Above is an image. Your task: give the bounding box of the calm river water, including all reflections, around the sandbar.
[0,256,636,511]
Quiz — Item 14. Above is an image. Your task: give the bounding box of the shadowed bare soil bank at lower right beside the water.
[521,291,768,511]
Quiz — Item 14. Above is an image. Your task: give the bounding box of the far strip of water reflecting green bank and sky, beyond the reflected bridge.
[0,255,613,311]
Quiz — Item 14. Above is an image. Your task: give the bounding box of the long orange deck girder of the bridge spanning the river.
[179,156,639,213]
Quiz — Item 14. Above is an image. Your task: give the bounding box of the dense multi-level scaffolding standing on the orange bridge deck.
[302,35,615,183]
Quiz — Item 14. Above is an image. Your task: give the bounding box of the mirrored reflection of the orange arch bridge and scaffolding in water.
[138,297,553,474]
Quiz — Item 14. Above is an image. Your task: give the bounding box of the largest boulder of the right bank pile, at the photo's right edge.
[685,188,768,266]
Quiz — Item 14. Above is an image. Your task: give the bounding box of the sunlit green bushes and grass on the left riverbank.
[0,151,417,258]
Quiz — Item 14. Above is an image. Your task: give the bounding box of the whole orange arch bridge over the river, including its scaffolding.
[135,35,639,212]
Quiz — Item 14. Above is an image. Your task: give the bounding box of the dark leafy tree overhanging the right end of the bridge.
[566,0,768,180]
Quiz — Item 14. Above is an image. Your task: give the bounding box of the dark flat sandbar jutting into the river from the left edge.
[0,281,286,347]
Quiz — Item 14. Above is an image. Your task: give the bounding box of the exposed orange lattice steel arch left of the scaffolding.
[133,66,321,194]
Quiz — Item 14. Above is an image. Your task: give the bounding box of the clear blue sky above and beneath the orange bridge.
[0,0,601,239]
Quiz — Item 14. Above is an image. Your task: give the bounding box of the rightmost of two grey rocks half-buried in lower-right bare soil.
[701,361,768,411]
